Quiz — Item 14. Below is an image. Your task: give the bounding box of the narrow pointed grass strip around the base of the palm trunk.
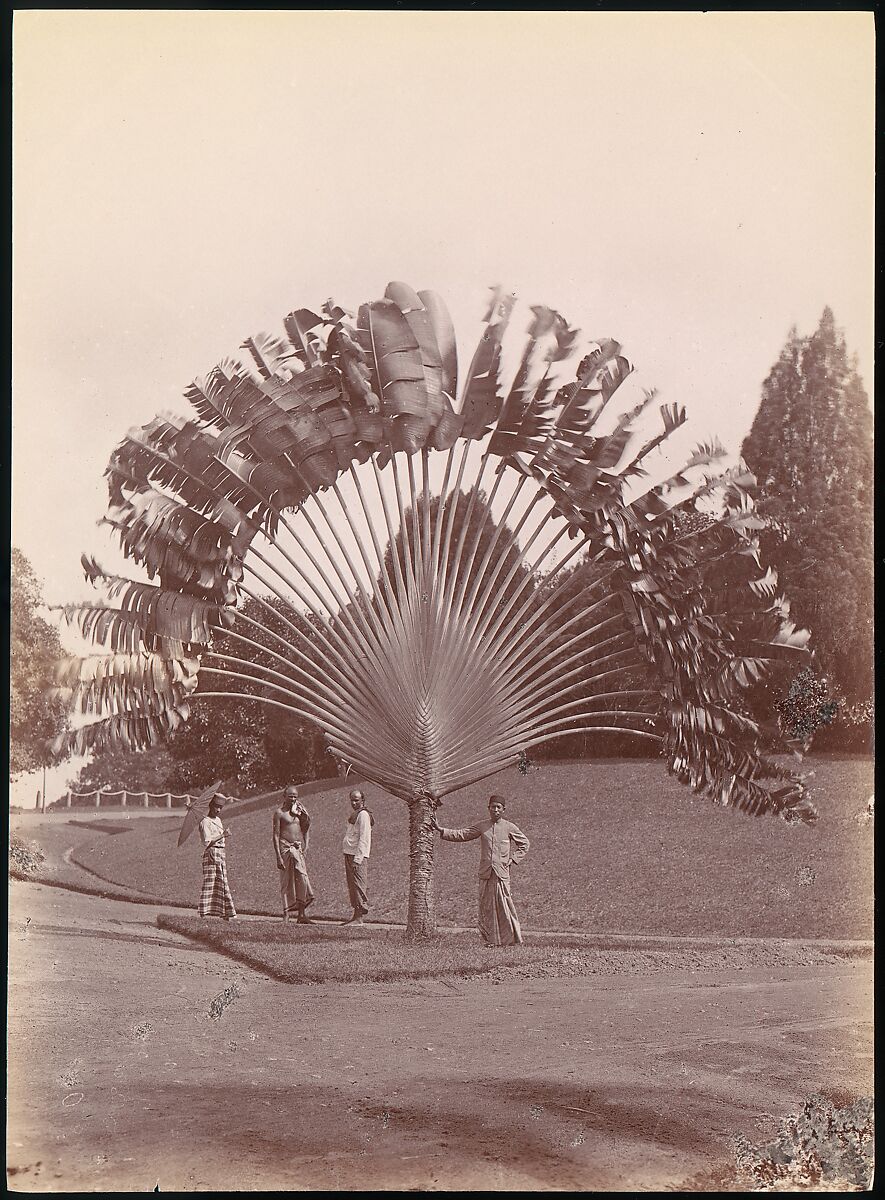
[157,913,858,984]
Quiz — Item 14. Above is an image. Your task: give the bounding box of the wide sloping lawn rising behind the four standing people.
[68,760,873,938]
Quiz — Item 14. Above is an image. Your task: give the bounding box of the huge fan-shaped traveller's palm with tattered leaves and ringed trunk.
[53,283,814,936]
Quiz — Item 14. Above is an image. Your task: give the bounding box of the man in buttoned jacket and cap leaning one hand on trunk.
[433,796,529,946]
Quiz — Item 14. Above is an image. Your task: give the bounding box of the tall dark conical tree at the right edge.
[742,308,873,742]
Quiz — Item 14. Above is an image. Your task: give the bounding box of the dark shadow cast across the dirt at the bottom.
[108,1078,730,1190]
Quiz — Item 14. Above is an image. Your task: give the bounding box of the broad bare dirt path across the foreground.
[8,883,872,1192]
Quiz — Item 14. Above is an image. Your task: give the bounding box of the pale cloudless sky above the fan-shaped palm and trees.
[13,10,874,602]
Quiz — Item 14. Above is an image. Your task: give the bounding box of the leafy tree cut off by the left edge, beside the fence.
[10,546,67,775]
